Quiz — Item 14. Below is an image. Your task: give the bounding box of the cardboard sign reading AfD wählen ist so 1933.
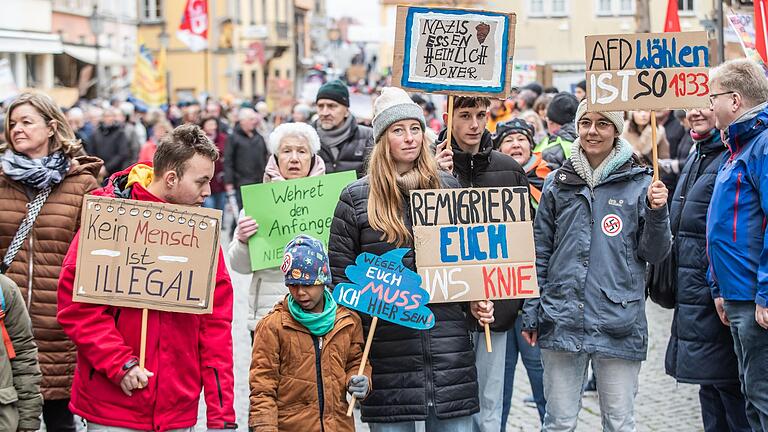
[586,31,709,111]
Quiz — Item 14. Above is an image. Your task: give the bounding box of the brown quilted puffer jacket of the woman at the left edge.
[0,156,103,400]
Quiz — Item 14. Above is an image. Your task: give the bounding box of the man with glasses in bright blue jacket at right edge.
[707,59,768,430]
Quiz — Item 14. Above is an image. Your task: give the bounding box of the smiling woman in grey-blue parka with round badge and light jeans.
[523,100,671,432]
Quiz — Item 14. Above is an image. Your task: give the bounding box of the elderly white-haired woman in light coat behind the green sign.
[227,123,325,337]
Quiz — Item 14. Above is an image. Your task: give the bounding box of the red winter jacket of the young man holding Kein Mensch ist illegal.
[57,164,235,431]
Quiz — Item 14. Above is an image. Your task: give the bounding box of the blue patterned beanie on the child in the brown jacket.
[280,234,331,285]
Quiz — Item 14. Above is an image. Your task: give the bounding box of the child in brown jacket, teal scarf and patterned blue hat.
[248,235,371,432]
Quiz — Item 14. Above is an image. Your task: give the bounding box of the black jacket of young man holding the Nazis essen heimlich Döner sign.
[438,129,533,332]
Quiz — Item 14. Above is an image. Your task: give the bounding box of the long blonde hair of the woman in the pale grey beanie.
[368,126,440,247]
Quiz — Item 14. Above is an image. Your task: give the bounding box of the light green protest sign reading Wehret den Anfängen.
[240,171,357,271]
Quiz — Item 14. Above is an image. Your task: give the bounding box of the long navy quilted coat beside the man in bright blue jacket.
[665,133,739,385]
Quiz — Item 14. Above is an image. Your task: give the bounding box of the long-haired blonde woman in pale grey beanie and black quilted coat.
[328,87,493,432]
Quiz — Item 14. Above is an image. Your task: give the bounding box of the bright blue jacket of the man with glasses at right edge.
[707,107,768,307]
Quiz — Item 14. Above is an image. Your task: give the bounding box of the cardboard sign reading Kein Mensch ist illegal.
[73,196,221,314]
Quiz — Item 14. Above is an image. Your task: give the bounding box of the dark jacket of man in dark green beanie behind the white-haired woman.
[312,114,373,178]
